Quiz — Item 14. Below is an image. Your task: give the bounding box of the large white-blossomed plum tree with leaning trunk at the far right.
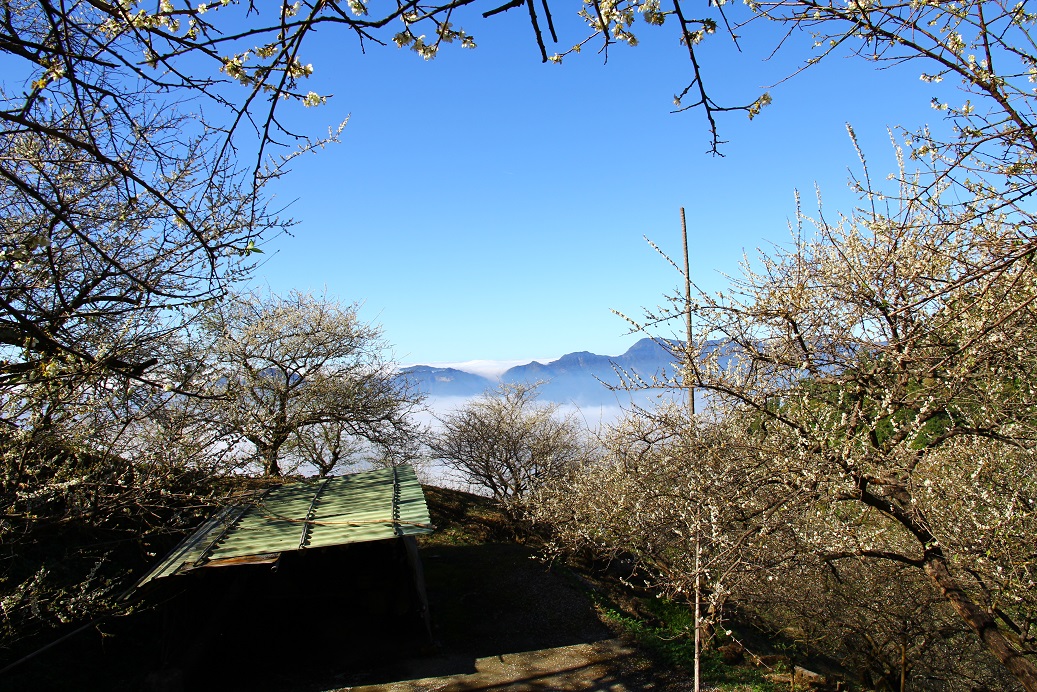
[630,150,1037,690]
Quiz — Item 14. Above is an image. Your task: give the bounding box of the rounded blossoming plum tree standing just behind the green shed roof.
[200,292,418,476]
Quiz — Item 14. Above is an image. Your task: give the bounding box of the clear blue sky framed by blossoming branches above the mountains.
[248,5,938,363]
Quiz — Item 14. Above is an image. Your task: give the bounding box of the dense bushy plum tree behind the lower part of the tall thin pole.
[529,404,798,645]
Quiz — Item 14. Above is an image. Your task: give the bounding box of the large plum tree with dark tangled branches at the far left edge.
[0,93,281,530]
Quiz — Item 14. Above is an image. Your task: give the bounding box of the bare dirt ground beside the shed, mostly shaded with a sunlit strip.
[327,544,658,692]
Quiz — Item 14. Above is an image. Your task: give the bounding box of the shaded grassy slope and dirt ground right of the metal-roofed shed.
[342,487,817,692]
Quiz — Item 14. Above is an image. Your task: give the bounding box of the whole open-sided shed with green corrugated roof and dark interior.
[130,466,433,689]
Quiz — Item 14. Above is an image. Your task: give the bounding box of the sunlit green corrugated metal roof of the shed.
[137,466,432,588]
